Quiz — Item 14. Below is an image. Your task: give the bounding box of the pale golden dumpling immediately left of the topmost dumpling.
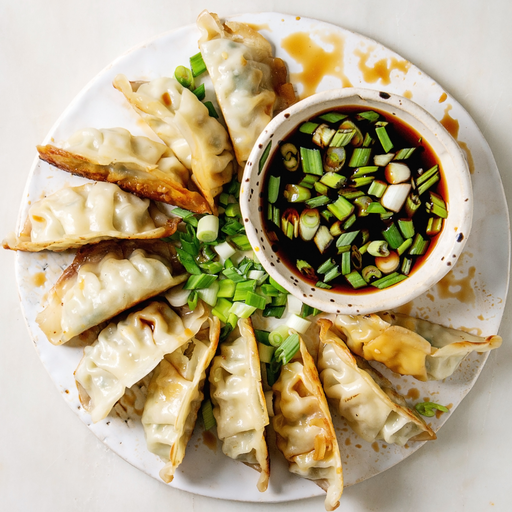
[114,75,234,211]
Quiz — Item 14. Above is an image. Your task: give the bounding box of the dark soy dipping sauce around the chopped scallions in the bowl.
[260,106,448,294]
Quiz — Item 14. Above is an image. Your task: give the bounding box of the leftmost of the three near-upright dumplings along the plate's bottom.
[142,317,220,483]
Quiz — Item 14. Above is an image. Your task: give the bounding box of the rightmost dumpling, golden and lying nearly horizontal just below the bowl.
[334,313,501,381]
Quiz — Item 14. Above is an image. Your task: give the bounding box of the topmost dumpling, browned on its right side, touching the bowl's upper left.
[197,11,296,166]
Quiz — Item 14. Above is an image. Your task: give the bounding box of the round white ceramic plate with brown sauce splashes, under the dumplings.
[16,13,510,502]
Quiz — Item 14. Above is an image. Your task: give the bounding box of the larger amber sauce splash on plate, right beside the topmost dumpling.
[281,32,352,99]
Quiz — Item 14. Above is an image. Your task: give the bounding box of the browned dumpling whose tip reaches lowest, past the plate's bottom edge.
[272,339,343,510]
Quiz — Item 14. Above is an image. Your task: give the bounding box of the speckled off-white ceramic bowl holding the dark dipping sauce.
[240,88,473,314]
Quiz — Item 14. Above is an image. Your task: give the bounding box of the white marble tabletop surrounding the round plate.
[0,0,512,512]
